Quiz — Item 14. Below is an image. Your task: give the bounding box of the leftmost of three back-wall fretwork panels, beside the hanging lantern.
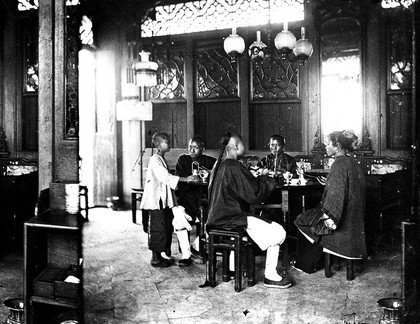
[150,48,185,99]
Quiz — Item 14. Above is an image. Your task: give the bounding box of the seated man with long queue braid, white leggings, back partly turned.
[206,133,292,288]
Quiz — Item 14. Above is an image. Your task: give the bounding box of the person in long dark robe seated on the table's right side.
[295,131,367,272]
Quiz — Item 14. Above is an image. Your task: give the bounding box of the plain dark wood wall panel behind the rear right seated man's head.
[249,103,302,152]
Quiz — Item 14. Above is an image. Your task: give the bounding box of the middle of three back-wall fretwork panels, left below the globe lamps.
[196,49,238,99]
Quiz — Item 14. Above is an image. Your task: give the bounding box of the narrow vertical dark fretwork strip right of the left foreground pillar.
[65,4,80,139]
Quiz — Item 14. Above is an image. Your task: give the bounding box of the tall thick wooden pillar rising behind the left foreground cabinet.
[38,0,79,190]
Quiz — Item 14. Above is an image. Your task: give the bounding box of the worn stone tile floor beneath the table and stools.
[0,208,401,324]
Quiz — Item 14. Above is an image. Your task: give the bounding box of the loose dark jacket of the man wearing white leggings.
[206,159,276,230]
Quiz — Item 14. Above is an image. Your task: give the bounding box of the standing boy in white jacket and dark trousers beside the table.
[140,132,194,268]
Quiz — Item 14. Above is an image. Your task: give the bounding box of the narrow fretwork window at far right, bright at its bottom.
[387,13,413,90]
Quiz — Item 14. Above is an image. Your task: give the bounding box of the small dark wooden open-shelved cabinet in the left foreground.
[24,210,83,324]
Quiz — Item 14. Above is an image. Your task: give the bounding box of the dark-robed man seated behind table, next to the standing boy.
[176,136,216,254]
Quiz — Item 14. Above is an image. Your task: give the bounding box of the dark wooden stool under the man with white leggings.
[208,229,255,292]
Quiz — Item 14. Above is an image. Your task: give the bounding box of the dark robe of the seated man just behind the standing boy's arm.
[176,154,216,222]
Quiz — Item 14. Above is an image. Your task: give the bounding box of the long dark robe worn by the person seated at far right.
[295,156,367,258]
